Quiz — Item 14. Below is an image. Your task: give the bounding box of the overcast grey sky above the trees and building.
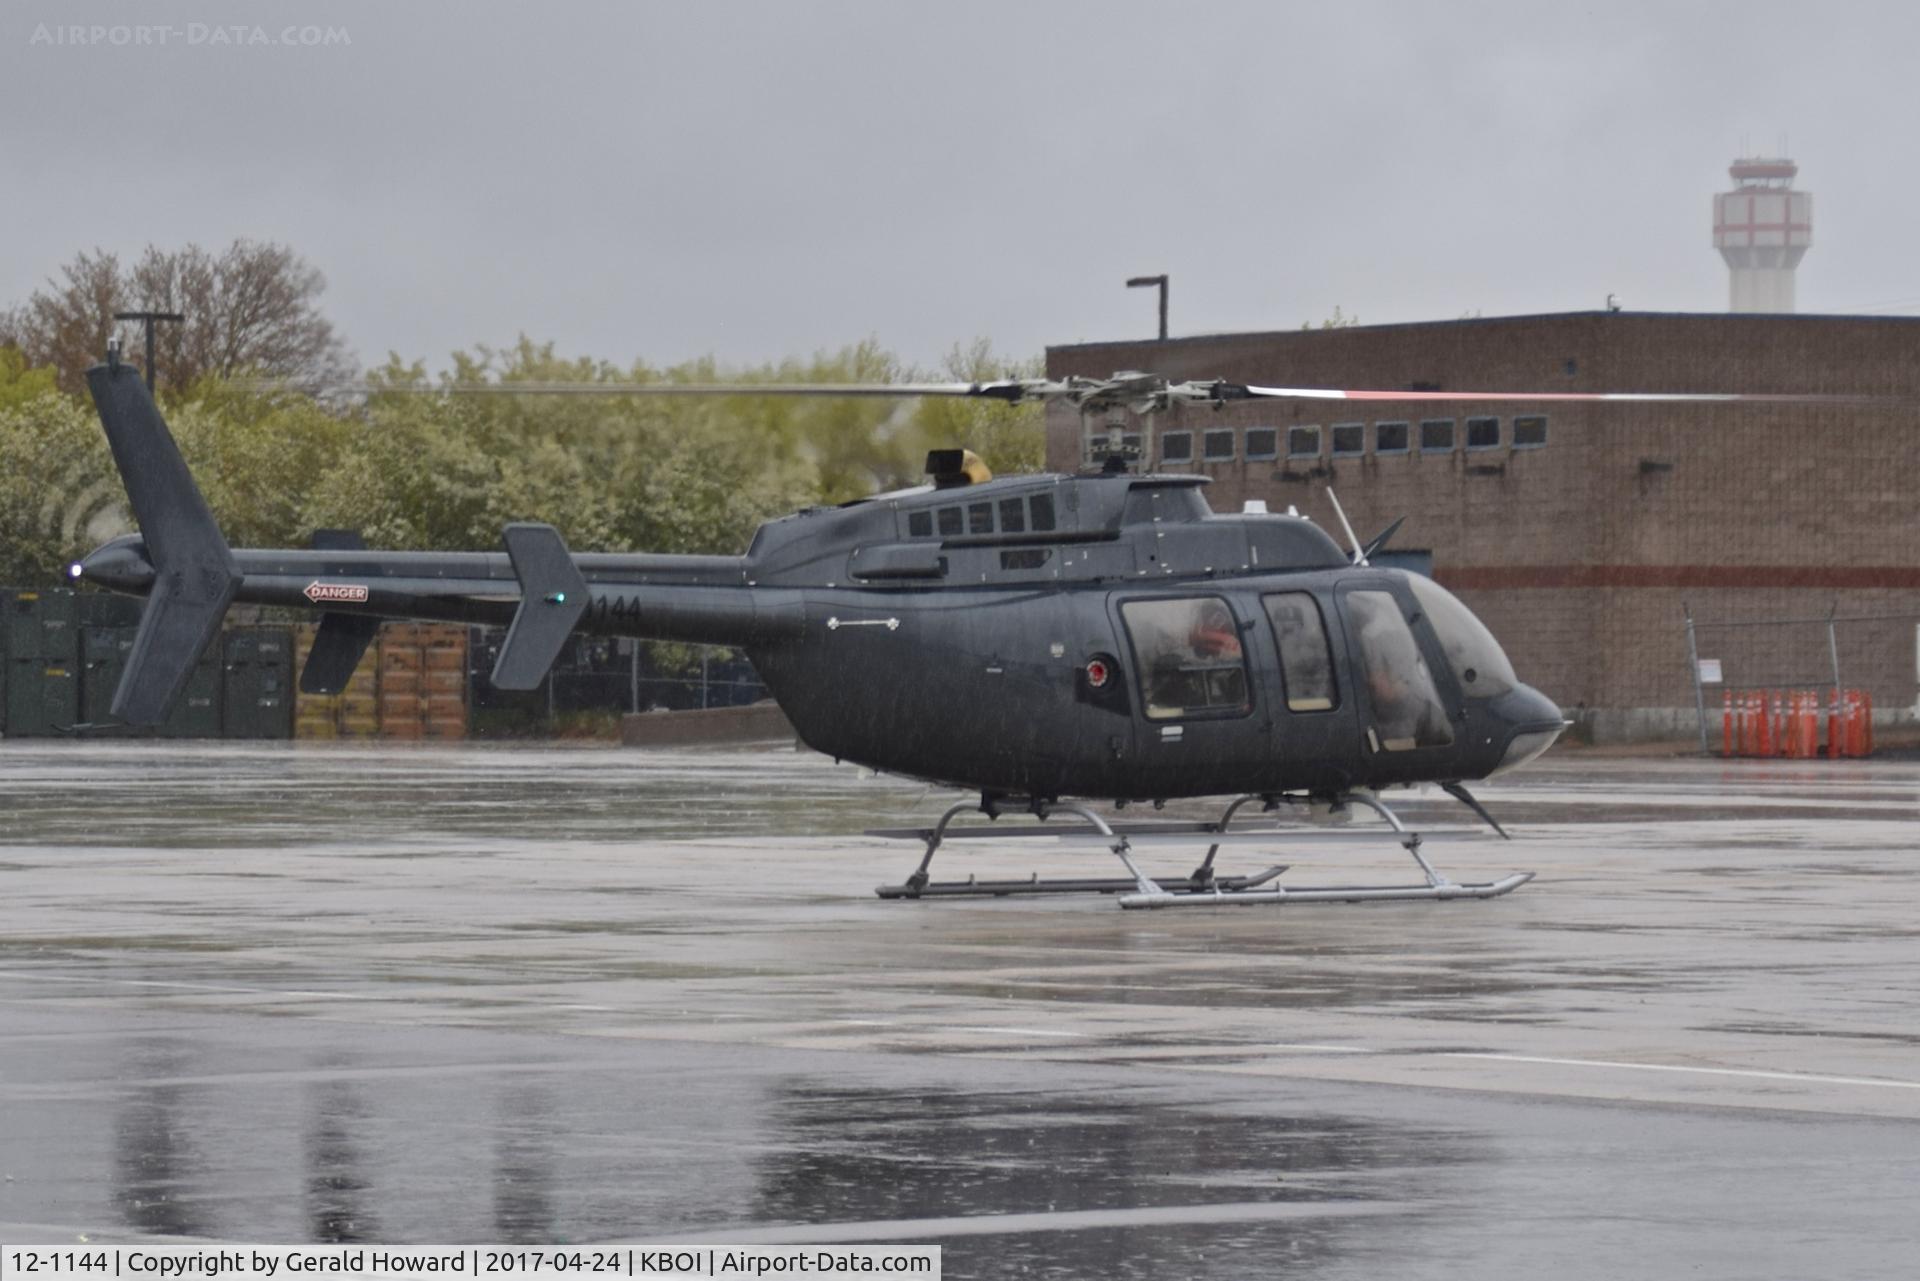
[0,0,1920,376]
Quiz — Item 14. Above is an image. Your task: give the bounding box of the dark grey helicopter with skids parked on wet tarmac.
[71,348,1834,906]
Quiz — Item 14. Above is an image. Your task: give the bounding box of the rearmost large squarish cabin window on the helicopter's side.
[1119,595,1250,720]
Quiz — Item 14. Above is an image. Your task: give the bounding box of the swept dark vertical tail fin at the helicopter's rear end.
[86,361,240,724]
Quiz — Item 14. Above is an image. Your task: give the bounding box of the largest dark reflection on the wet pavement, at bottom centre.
[751,1081,1484,1277]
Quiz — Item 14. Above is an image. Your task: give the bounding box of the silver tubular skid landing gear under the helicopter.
[868,787,1534,908]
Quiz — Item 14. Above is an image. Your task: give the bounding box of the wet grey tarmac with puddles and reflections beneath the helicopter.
[0,743,1920,1277]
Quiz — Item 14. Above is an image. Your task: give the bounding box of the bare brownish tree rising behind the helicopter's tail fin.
[0,240,351,392]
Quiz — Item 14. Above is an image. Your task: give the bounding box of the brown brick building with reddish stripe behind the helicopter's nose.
[1046,311,1920,739]
